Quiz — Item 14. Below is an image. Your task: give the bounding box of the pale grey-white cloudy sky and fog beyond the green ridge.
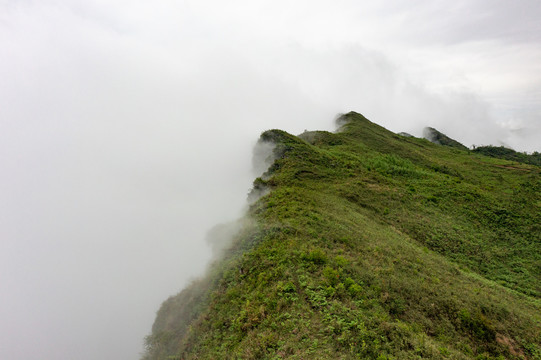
[0,0,541,360]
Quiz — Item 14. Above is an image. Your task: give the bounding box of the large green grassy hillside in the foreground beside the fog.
[144,112,541,359]
